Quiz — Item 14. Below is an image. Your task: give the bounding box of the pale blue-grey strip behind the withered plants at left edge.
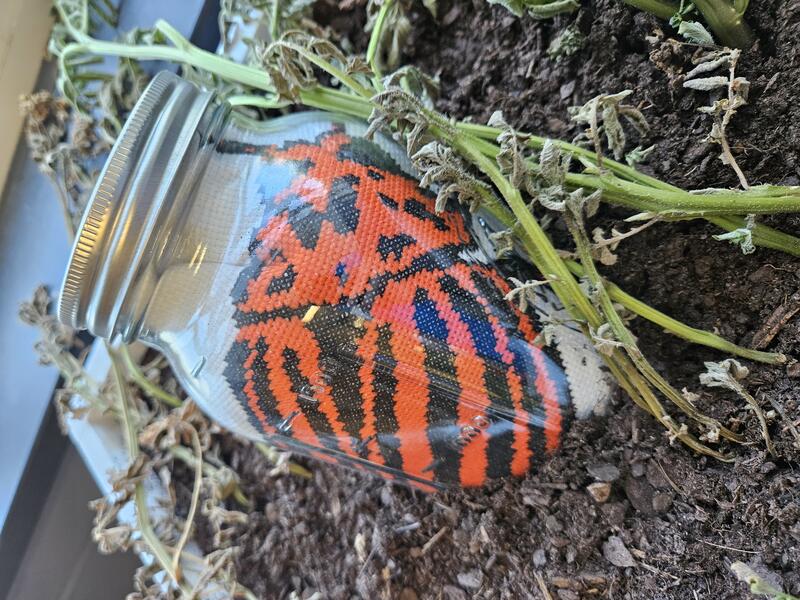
[0,0,209,530]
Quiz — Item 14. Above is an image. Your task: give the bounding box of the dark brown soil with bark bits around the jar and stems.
[184,0,800,600]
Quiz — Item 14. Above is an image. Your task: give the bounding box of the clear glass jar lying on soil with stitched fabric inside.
[59,73,608,487]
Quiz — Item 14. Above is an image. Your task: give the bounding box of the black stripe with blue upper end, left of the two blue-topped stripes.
[409,288,461,483]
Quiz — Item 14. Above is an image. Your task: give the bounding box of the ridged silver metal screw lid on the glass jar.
[58,71,214,338]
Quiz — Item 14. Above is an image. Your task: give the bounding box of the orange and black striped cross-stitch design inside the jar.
[218,127,570,488]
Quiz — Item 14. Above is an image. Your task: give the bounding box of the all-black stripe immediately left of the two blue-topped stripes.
[372,325,403,471]
